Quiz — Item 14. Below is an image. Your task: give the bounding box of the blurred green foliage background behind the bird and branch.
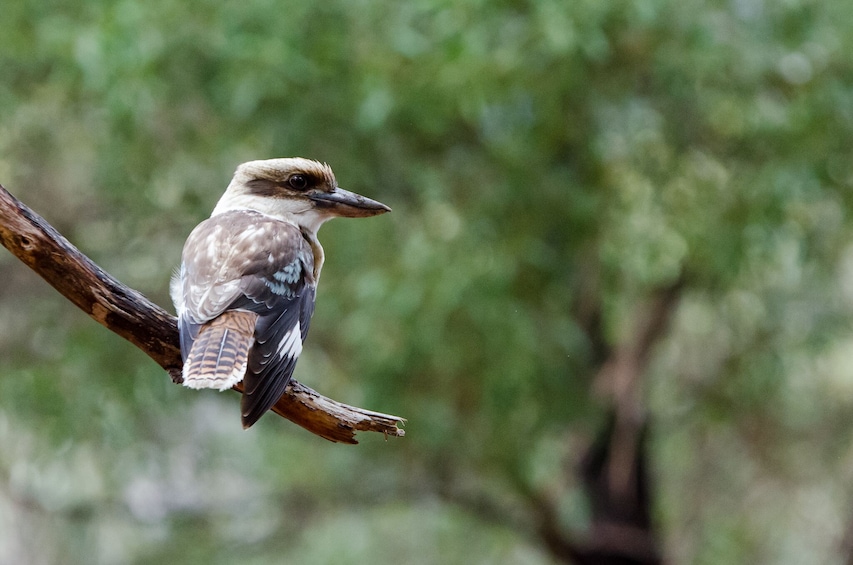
[0,0,853,565]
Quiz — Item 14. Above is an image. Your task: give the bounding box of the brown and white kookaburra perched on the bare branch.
[171,158,391,428]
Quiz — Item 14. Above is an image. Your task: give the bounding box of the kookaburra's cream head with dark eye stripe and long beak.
[213,157,391,233]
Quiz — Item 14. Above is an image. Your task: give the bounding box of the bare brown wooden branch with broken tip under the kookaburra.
[0,186,405,444]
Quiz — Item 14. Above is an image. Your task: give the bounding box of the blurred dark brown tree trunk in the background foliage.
[540,280,684,565]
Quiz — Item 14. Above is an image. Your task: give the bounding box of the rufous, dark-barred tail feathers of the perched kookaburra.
[184,310,258,390]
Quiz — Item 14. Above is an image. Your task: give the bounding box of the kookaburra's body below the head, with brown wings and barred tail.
[173,210,322,427]
